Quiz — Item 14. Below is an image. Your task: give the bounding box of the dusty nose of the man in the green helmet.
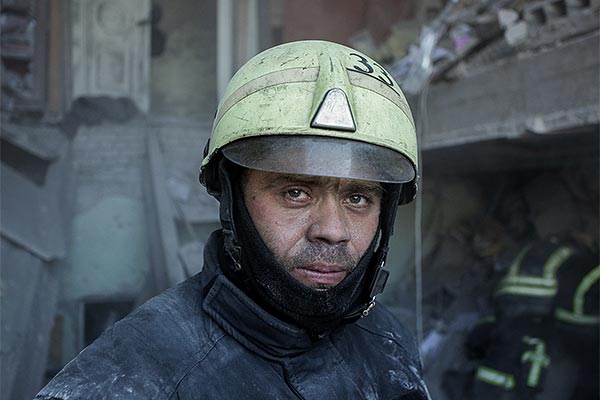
[307,194,350,244]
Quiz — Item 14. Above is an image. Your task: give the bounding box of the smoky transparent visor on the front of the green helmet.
[222,135,415,183]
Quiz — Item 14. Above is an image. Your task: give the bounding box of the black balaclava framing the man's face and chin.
[216,162,397,335]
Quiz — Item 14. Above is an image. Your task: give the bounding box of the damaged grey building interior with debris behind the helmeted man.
[0,0,600,400]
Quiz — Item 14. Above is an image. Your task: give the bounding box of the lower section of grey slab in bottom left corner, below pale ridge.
[0,238,60,400]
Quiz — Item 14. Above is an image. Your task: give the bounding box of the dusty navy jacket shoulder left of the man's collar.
[36,276,222,400]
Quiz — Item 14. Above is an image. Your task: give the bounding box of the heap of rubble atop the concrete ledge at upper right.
[371,0,600,87]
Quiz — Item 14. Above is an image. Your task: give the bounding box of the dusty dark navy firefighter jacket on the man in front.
[36,232,427,400]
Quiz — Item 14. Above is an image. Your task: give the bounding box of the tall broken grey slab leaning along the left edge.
[0,121,72,400]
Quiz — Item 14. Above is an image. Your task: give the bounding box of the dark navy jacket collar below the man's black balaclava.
[202,233,313,358]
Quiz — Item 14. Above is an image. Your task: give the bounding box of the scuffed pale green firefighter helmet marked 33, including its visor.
[201,41,417,203]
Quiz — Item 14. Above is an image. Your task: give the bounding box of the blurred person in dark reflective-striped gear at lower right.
[458,236,600,400]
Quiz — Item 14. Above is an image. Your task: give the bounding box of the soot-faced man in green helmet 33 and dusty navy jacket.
[37,41,428,400]
